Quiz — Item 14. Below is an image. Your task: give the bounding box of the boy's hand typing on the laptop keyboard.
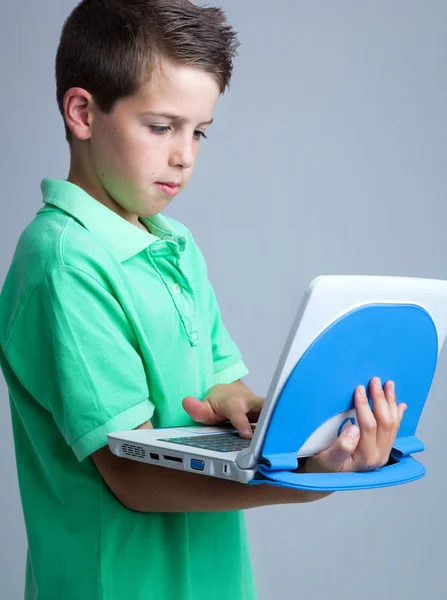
[182,381,264,439]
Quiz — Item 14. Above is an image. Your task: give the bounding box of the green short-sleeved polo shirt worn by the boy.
[0,179,256,600]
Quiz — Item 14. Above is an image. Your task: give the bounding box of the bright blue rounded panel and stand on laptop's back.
[251,304,438,491]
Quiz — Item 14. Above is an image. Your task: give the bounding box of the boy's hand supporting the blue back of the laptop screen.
[304,377,407,473]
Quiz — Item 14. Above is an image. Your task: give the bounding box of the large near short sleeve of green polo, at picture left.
[3,266,154,460]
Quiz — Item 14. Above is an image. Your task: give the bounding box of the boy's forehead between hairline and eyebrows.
[124,63,220,121]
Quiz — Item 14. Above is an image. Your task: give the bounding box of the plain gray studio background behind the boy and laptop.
[0,0,447,600]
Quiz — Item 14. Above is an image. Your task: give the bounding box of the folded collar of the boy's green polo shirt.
[40,177,185,262]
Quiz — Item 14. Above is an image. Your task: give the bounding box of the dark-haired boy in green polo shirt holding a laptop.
[0,0,405,600]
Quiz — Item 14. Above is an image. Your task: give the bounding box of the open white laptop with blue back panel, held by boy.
[108,275,447,490]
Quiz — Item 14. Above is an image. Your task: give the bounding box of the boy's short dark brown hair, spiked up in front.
[56,0,239,141]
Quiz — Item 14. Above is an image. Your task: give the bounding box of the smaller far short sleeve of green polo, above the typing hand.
[208,281,248,385]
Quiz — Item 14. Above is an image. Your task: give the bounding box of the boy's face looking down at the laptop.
[85,63,220,220]
